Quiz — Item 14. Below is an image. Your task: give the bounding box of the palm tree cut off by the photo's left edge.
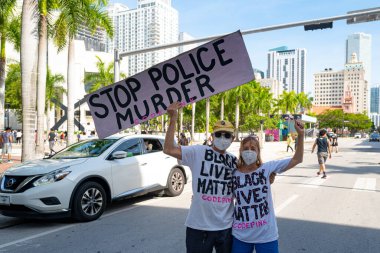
[0,0,16,129]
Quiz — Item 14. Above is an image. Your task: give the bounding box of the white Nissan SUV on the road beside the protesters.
[0,135,190,221]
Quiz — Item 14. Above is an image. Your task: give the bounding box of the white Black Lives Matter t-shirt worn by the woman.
[232,158,291,243]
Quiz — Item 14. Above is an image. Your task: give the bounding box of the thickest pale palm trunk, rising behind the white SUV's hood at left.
[20,0,38,161]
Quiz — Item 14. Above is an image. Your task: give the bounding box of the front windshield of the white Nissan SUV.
[51,139,117,159]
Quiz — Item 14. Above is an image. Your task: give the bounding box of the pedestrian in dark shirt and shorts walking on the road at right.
[311,129,331,178]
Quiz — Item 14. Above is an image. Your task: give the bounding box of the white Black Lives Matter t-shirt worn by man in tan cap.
[181,145,237,231]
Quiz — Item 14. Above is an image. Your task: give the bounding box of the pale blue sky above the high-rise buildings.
[110,0,380,95]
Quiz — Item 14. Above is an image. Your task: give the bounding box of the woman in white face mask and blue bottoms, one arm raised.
[232,120,304,253]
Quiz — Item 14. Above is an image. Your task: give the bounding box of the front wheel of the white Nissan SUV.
[73,182,107,221]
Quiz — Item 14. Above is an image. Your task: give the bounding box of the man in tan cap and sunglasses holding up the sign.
[164,102,237,253]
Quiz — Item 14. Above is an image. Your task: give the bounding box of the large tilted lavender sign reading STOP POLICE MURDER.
[86,31,254,138]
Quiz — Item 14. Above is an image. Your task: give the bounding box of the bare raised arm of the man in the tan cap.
[164,102,182,160]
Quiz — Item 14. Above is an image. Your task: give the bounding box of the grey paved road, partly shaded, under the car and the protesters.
[0,139,380,253]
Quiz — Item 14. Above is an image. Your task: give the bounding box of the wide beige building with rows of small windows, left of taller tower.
[313,68,344,106]
